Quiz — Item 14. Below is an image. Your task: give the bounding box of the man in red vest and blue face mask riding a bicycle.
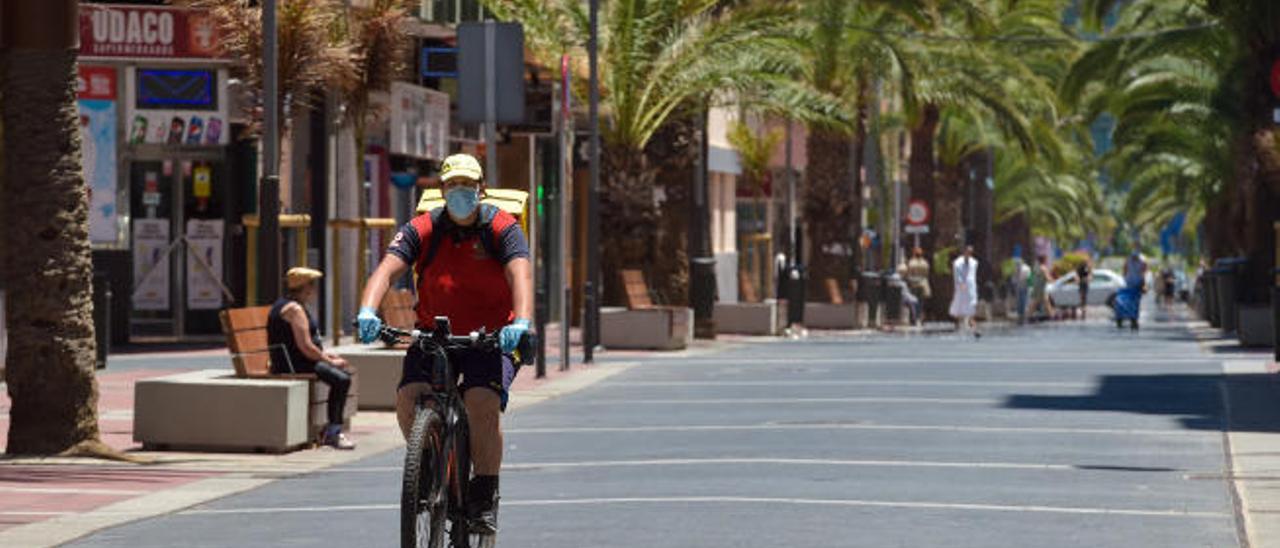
[357,154,534,534]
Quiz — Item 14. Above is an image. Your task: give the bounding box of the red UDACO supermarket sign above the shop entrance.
[79,4,220,59]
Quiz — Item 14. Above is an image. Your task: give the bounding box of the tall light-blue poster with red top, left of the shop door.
[76,65,120,245]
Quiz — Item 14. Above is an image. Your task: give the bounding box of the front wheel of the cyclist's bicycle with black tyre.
[401,407,449,548]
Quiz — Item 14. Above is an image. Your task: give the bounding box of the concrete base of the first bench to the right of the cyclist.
[600,307,694,350]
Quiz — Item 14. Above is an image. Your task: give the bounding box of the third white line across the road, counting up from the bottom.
[506,423,1203,437]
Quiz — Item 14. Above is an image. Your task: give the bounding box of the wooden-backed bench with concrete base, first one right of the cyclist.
[600,270,694,350]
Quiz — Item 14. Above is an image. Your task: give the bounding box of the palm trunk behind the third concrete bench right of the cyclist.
[804,127,859,302]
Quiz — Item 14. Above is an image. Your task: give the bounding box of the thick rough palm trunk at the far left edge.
[0,41,99,455]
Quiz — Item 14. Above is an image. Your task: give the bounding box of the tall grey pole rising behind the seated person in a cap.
[257,0,280,302]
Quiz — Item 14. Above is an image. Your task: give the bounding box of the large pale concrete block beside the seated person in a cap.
[133,369,311,452]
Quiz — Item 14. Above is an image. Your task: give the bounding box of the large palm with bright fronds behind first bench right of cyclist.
[485,0,841,303]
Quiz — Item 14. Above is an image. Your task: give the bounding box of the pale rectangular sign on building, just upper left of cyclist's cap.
[390,82,449,160]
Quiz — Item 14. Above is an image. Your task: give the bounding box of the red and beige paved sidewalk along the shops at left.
[0,343,670,548]
